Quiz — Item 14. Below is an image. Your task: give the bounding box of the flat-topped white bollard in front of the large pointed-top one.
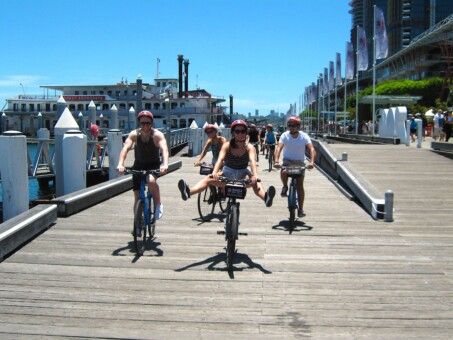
[62,130,87,195]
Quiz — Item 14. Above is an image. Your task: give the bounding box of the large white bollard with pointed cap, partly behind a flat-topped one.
[54,108,80,197]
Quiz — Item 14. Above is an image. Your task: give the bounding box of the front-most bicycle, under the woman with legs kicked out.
[211,175,259,269]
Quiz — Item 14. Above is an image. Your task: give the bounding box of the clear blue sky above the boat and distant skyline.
[0,0,351,115]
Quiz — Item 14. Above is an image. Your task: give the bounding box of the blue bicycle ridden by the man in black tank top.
[125,168,160,255]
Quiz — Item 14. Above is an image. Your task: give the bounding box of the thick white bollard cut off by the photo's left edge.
[0,131,29,221]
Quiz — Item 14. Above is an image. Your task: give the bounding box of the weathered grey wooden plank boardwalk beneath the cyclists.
[0,144,453,339]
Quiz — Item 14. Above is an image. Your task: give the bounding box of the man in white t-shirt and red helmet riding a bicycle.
[274,117,316,217]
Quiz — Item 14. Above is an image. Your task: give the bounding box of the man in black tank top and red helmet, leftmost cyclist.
[117,111,168,219]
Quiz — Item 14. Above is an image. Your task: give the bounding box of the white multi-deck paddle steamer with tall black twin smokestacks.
[3,55,226,136]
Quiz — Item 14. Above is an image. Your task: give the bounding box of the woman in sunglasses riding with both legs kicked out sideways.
[178,120,275,207]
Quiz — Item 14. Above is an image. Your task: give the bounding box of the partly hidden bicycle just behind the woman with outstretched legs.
[198,163,226,222]
